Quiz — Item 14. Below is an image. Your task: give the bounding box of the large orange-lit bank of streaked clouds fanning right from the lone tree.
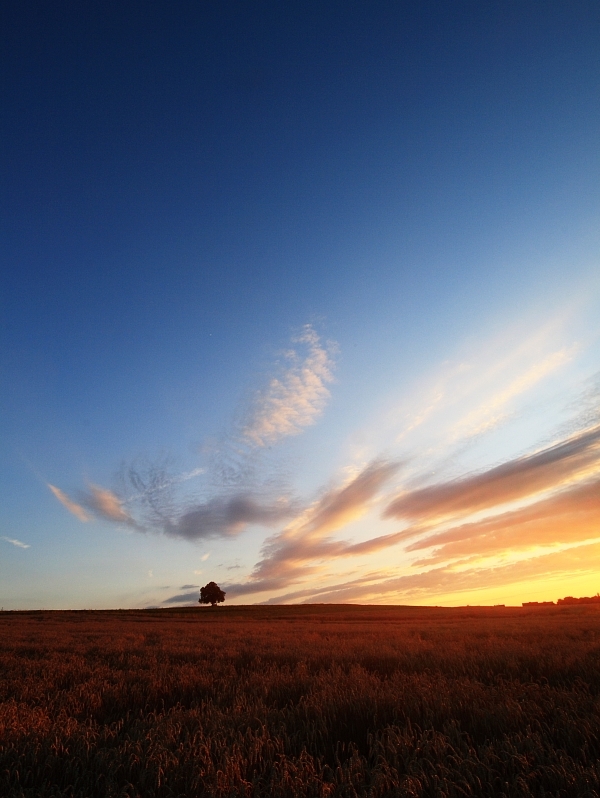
[224,427,600,601]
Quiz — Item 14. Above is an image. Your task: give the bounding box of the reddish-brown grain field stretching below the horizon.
[0,605,600,798]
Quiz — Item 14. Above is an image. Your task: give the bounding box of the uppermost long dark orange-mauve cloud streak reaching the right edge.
[383,426,600,522]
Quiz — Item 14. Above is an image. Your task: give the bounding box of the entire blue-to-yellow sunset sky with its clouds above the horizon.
[0,0,600,610]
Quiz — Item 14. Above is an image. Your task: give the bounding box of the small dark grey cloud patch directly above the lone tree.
[163,495,293,544]
